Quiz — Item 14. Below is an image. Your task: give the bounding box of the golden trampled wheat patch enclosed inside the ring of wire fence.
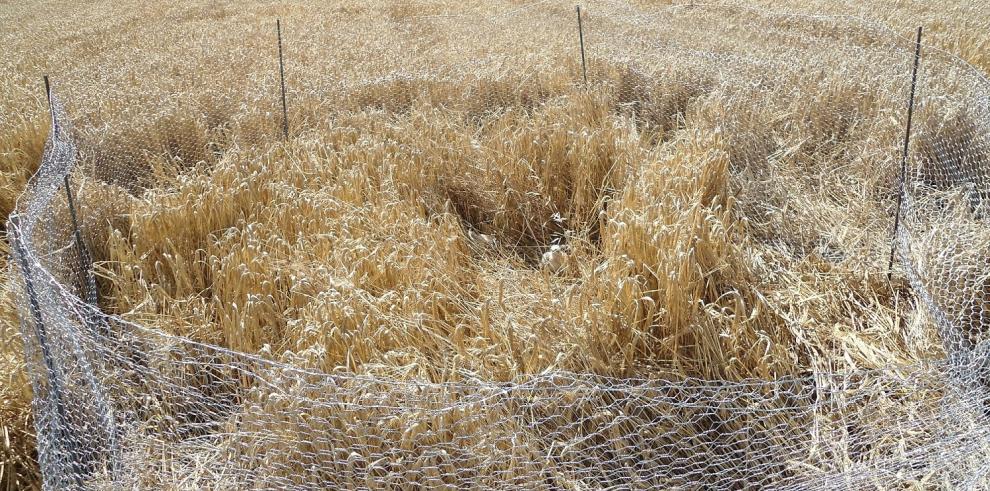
[68,58,938,381]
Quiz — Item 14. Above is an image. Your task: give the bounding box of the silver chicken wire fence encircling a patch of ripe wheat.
[8,2,990,489]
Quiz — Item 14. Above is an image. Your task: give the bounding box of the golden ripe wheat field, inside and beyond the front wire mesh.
[0,0,990,490]
